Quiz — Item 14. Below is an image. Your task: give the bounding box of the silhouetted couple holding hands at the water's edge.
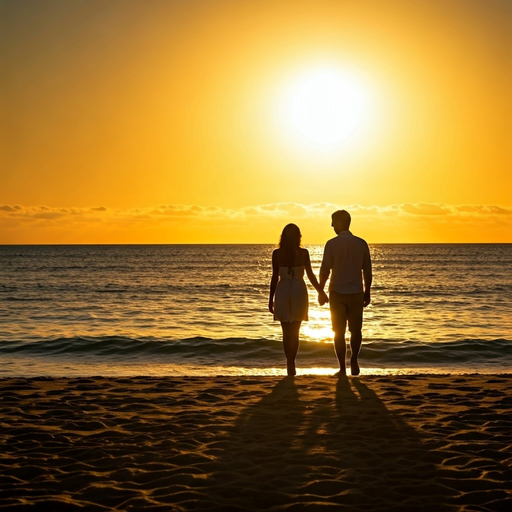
[268,210,372,376]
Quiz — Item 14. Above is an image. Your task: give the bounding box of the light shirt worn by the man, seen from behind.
[320,231,372,293]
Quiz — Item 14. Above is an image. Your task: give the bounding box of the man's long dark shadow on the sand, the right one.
[327,379,453,512]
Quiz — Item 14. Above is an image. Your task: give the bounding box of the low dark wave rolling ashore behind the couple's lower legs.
[0,336,512,370]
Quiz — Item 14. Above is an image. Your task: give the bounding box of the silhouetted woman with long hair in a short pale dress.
[268,224,328,375]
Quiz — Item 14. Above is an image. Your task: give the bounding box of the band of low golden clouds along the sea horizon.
[0,202,512,244]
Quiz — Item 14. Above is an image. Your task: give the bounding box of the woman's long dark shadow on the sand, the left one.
[196,378,306,511]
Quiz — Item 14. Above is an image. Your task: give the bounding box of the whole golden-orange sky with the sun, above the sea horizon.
[0,0,512,243]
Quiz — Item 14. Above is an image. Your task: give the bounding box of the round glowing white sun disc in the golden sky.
[278,65,371,154]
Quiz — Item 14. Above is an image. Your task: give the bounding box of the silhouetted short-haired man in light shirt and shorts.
[318,210,372,375]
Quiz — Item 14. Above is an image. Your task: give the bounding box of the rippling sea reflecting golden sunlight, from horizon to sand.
[0,244,512,377]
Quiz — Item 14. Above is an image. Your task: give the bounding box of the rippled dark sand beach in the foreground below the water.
[0,375,512,512]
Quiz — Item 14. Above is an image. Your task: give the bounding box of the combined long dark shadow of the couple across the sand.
[195,378,453,512]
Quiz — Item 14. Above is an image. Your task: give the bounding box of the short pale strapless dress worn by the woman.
[274,266,308,322]
